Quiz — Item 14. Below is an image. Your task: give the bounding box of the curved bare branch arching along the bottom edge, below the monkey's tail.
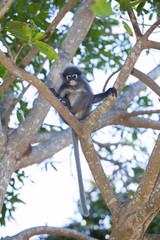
[3,226,98,240]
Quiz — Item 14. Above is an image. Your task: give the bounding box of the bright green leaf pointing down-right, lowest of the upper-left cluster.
[33,41,59,61]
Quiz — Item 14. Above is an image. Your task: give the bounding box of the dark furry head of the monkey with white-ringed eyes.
[62,66,81,86]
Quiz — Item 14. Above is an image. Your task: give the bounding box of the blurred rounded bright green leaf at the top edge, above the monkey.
[91,0,114,18]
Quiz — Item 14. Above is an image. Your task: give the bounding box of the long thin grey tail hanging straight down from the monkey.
[72,129,89,217]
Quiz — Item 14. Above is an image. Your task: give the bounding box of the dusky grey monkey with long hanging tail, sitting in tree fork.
[50,66,117,217]
